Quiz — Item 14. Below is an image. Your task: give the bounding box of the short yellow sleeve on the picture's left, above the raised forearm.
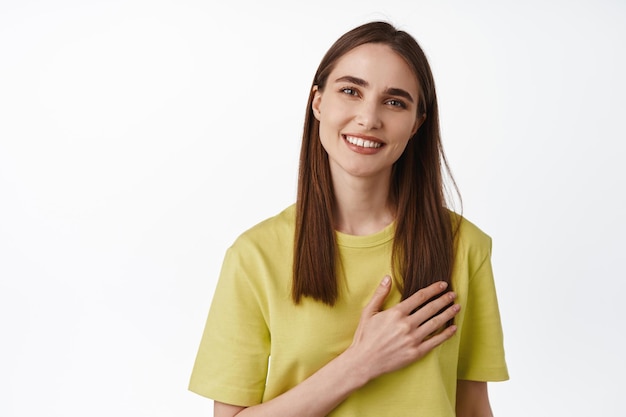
[189,242,270,406]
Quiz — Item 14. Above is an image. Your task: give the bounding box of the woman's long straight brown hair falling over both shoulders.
[292,22,458,306]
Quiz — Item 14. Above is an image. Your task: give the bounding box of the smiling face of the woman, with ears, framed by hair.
[312,43,424,182]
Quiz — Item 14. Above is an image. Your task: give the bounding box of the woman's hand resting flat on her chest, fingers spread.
[345,276,460,381]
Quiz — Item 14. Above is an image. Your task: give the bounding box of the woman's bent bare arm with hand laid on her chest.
[214,277,460,417]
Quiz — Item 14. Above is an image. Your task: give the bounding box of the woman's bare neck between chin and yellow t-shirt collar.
[333,168,394,236]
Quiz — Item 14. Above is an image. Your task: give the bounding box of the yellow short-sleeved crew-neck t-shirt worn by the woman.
[189,206,508,417]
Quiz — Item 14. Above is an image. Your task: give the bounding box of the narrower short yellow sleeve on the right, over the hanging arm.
[457,239,509,381]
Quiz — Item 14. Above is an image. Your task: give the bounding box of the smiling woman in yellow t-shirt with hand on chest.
[190,22,508,417]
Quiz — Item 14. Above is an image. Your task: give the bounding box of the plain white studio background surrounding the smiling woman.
[0,0,626,417]
